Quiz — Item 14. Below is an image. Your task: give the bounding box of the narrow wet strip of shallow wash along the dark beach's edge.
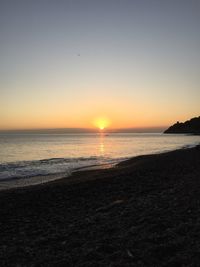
[0,144,199,192]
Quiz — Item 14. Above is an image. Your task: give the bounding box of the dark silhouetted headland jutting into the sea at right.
[164,116,200,134]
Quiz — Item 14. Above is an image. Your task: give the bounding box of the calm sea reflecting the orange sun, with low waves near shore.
[0,133,200,180]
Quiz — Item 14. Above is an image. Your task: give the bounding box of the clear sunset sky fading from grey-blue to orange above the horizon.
[0,0,200,129]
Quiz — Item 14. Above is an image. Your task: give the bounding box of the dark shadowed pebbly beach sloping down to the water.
[0,146,200,267]
